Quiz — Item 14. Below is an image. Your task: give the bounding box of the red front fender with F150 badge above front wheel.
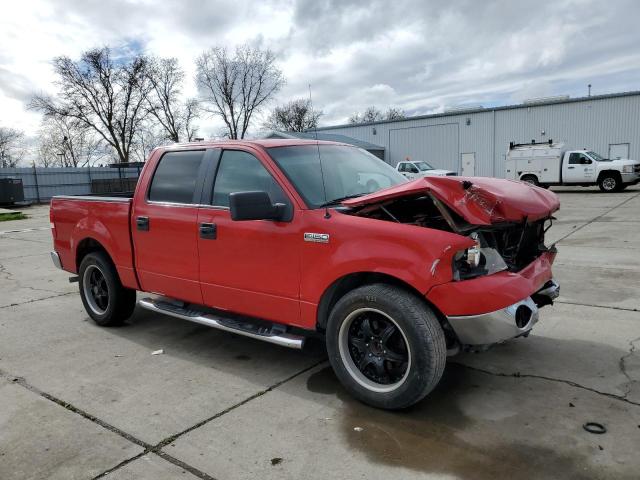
[300,210,474,325]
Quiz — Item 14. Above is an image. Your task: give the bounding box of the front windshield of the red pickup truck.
[268,144,407,208]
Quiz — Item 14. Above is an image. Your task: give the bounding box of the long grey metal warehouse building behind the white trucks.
[318,91,640,177]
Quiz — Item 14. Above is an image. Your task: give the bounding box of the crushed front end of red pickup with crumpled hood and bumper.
[344,177,559,347]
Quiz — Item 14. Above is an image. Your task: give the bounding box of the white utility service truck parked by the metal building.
[505,140,640,192]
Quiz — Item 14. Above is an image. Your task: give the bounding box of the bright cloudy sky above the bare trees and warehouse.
[0,0,640,137]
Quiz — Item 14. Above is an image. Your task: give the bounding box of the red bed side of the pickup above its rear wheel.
[50,194,137,288]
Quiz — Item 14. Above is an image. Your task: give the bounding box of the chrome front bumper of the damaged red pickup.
[447,279,560,346]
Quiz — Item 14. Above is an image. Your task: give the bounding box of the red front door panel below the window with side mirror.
[198,208,302,324]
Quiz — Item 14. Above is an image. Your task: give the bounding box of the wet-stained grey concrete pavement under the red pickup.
[0,188,640,479]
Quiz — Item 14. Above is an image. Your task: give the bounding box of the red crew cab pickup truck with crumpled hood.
[50,140,559,409]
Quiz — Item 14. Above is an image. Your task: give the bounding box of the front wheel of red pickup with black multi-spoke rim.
[326,284,447,409]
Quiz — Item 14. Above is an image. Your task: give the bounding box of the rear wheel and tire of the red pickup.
[78,252,136,327]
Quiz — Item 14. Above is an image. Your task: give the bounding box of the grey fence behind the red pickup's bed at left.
[0,166,142,203]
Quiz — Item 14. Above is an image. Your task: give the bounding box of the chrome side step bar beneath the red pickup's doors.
[138,298,305,350]
